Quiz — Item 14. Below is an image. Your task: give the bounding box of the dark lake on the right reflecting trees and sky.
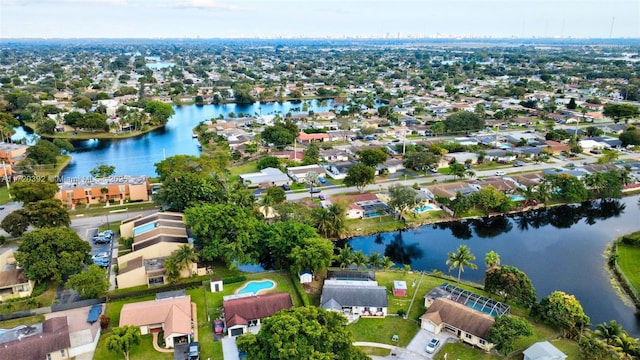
[348,195,640,337]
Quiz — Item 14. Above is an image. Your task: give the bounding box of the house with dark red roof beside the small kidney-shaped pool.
[222,292,293,337]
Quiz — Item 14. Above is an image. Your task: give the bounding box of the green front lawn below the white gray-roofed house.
[348,316,420,346]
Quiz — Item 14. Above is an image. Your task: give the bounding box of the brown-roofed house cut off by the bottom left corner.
[0,316,71,360]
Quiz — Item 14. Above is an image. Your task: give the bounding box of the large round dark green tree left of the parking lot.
[16,228,91,283]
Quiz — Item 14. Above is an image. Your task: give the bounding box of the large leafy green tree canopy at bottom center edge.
[237,306,369,360]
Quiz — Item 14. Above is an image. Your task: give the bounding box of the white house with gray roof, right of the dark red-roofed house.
[320,279,389,321]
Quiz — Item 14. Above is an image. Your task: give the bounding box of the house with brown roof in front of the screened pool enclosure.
[420,297,494,351]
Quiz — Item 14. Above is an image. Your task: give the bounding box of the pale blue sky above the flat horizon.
[0,0,640,38]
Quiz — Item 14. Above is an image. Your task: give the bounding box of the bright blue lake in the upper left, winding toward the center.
[58,100,332,177]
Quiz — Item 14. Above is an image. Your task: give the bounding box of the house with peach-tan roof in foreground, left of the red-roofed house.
[118,295,196,348]
